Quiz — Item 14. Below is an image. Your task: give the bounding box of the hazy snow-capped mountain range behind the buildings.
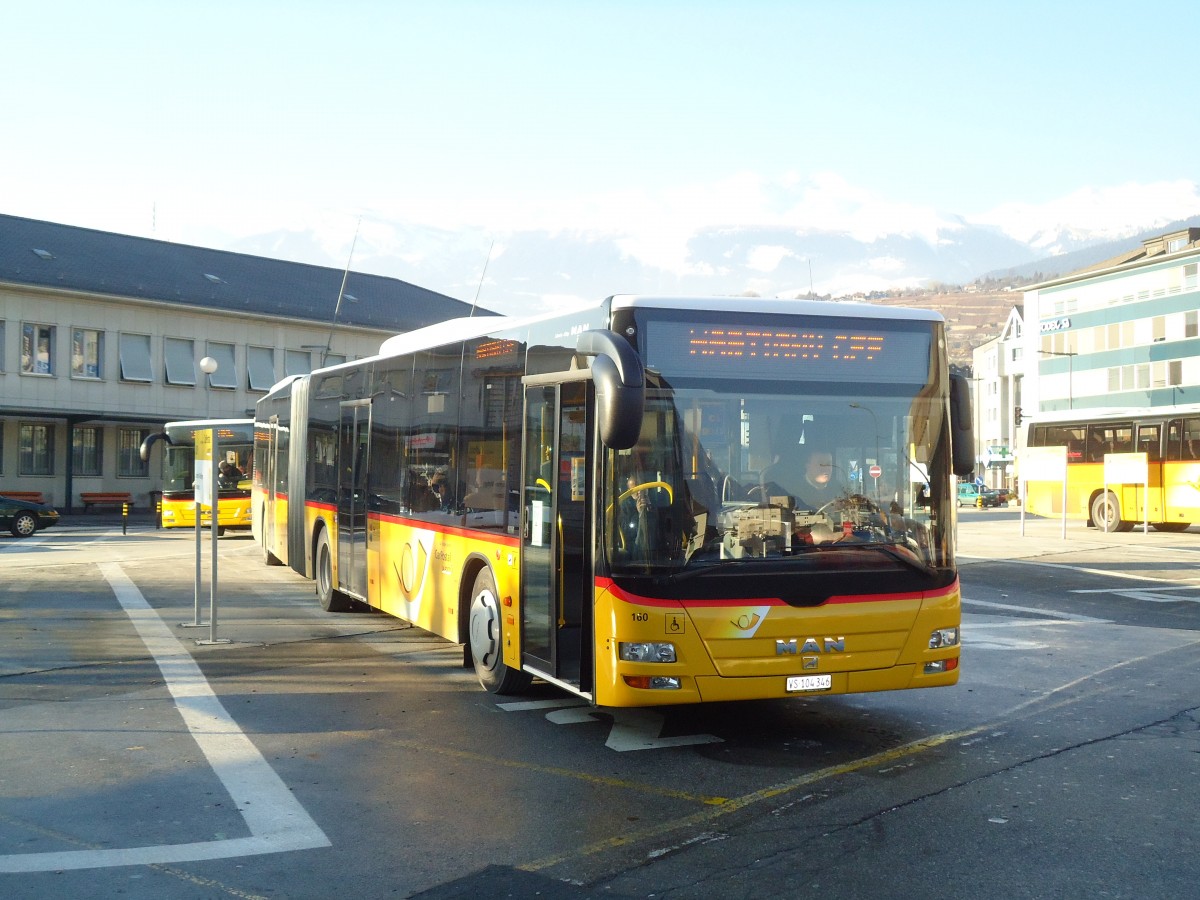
[229,217,1200,314]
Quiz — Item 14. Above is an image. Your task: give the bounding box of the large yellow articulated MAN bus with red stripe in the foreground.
[253,296,972,707]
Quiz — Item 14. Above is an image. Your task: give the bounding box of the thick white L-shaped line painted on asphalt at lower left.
[0,563,330,872]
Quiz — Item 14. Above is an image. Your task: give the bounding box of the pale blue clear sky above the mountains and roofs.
[7,0,1200,307]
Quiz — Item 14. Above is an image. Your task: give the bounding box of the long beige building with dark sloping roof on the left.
[0,215,490,509]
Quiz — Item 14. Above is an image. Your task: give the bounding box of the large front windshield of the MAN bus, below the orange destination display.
[602,378,954,576]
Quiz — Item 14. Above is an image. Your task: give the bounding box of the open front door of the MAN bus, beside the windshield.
[521,380,593,686]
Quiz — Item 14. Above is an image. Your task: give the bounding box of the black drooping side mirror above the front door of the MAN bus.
[575,330,646,450]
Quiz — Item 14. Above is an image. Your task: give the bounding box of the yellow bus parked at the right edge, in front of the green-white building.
[1025,406,1200,532]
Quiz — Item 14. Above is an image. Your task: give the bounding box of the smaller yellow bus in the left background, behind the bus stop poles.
[142,419,254,534]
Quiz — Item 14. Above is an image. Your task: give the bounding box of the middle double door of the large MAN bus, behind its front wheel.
[337,400,371,599]
